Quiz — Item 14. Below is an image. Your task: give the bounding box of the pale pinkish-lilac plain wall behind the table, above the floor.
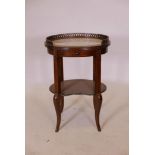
[26,0,129,86]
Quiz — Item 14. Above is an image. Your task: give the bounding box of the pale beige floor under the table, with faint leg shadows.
[26,82,129,155]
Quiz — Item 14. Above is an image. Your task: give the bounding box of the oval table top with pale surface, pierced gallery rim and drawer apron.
[45,33,110,57]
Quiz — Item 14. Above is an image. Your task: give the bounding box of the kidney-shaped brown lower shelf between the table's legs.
[49,79,106,96]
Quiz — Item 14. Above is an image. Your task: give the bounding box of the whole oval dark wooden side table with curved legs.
[45,33,110,132]
